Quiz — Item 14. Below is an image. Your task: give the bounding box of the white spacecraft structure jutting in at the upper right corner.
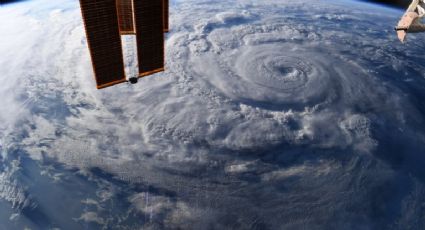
[395,0,425,43]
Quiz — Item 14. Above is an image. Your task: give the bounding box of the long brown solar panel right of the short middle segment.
[134,0,164,77]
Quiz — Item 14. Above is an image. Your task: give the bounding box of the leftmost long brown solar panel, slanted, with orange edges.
[80,0,126,89]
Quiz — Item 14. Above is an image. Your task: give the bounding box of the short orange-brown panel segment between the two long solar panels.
[116,0,135,35]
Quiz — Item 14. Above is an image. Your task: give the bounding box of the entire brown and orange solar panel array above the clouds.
[80,0,169,89]
